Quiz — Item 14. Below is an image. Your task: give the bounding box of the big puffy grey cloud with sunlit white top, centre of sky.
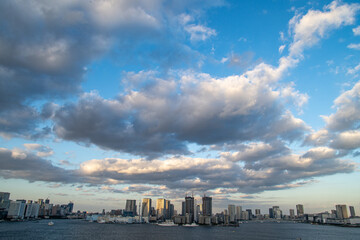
[53,72,308,158]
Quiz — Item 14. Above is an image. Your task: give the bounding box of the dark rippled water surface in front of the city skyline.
[0,219,360,240]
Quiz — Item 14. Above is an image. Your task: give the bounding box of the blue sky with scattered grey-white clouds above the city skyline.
[0,0,360,214]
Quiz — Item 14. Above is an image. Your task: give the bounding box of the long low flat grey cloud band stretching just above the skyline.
[0,145,355,196]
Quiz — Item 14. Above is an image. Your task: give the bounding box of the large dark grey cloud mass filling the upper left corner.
[0,0,221,138]
